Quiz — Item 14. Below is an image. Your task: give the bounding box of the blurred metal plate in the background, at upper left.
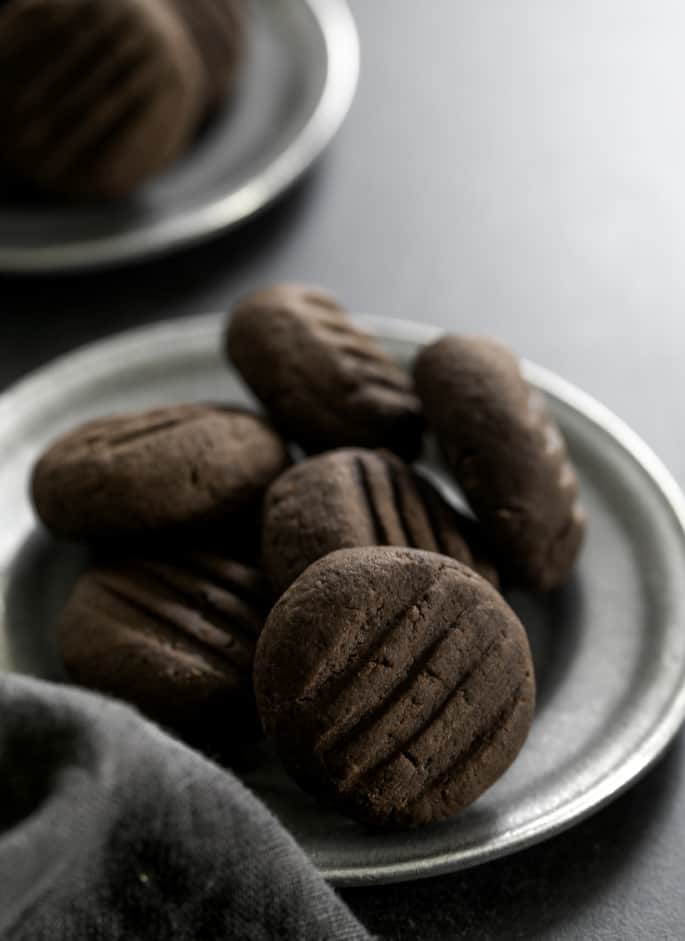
[0,0,359,272]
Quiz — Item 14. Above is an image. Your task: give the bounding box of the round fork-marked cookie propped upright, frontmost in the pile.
[254,547,535,826]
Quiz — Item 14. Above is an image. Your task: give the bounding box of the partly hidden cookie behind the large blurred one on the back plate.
[170,0,247,108]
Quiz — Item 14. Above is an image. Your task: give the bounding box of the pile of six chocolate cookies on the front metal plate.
[32,285,585,827]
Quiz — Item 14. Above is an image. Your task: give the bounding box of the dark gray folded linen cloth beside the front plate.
[0,675,368,941]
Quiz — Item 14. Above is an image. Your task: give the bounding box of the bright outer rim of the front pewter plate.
[0,314,685,886]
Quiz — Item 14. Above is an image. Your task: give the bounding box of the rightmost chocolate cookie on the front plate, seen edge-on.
[415,336,585,591]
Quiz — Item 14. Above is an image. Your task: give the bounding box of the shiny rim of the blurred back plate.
[0,0,360,274]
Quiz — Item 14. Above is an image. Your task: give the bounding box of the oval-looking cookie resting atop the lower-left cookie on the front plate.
[32,404,288,539]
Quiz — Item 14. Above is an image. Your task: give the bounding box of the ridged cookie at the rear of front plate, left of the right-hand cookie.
[227,285,423,457]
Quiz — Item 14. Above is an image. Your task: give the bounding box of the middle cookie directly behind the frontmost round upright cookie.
[262,448,497,592]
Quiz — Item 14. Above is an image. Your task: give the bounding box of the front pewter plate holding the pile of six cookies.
[0,317,685,885]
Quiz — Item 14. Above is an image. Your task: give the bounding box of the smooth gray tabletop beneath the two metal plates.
[0,0,685,941]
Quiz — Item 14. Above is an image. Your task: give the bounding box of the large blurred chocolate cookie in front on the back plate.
[0,0,207,197]
